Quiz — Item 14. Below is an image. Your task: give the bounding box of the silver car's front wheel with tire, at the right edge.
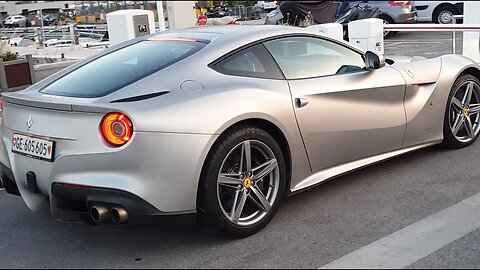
[443,74,480,148]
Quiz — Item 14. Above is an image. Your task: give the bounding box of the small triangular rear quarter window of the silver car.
[212,44,284,79]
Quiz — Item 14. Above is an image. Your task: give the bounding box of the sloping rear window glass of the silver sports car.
[41,40,206,98]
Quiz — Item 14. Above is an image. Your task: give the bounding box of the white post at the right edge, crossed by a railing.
[463,1,480,63]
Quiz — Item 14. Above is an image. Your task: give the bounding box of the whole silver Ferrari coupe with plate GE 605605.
[0,25,480,237]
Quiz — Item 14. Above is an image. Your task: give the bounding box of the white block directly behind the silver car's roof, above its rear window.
[167,1,197,30]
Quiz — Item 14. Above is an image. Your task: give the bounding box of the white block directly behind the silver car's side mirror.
[348,18,384,54]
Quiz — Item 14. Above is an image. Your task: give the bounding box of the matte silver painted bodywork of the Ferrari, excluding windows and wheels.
[0,26,479,220]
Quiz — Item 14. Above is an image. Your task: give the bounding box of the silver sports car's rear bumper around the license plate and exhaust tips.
[0,128,216,220]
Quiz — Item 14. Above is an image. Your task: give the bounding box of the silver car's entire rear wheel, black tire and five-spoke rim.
[198,126,286,237]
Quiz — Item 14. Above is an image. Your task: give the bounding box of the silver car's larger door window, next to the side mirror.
[264,37,365,79]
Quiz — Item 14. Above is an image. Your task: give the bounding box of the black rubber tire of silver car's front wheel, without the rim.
[442,74,480,149]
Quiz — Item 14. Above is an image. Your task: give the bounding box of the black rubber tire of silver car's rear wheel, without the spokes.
[197,126,287,238]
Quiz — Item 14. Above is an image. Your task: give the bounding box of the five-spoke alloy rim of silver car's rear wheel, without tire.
[217,140,280,227]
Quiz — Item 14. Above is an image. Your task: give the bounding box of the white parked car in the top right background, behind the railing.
[415,1,464,24]
